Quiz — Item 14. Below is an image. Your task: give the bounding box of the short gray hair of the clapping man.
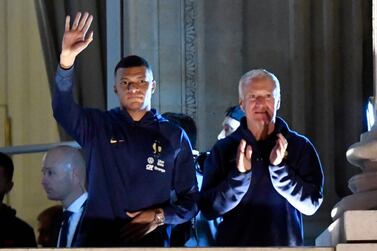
[238,69,280,99]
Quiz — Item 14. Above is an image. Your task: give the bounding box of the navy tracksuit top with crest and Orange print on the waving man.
[52,67,198,246]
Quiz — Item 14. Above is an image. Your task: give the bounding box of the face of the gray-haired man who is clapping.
[240,78,280,125]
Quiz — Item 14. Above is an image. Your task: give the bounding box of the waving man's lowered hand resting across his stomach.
[120,209,159,243]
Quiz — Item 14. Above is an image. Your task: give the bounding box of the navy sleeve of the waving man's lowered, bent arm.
[164,131,198,224]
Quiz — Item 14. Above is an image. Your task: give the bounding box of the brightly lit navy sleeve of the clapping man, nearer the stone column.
[269,140,323,215]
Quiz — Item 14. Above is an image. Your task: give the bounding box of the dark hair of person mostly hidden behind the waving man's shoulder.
[162,112,197,148]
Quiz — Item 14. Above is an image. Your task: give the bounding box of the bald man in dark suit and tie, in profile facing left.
[42,146,88,247]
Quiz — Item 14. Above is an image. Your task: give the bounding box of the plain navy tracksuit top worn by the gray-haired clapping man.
[199,117,323,246]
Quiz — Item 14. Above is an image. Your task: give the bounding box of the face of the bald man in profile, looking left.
[42,155,74,201]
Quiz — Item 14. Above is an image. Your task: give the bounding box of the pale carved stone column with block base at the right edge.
[316,1,377,246]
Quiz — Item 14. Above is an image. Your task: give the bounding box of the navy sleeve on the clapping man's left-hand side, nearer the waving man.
[199,145,252,219]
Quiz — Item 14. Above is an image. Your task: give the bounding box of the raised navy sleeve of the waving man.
[52,66,93,146]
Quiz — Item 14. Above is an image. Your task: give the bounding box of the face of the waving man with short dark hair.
[114,66,156,112]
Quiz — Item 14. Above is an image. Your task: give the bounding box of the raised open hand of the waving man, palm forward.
[60,12,93,68]
